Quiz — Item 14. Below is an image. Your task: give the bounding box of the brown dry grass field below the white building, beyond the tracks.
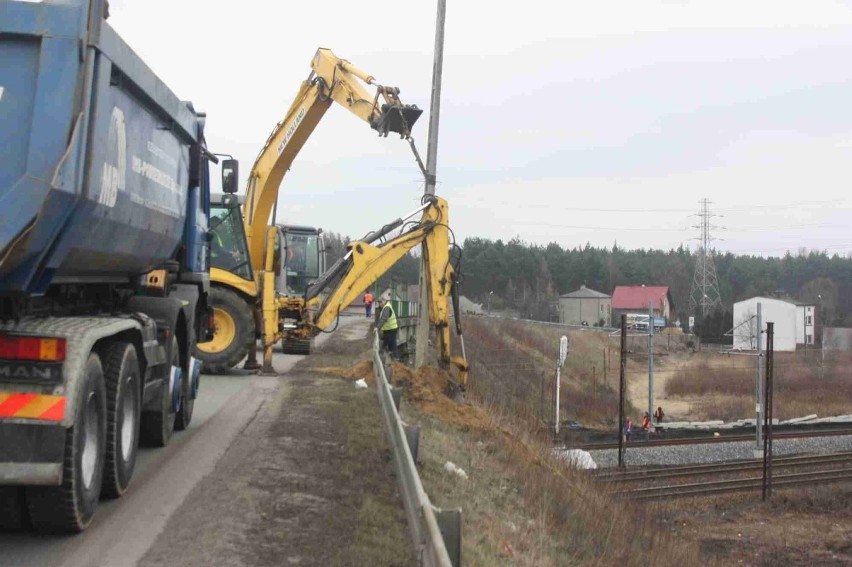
[666,351,852,420]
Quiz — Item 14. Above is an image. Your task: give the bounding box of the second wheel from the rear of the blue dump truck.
[101,342,142,498]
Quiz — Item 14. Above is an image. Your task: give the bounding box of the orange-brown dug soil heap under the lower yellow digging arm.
[392,362,492,429]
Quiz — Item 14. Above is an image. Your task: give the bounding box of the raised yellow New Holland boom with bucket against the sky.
[245,48,422,266]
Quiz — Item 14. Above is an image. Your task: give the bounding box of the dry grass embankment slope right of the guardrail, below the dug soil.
[404,400,706,566]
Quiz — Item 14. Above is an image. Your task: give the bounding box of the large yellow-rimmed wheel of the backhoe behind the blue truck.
[196,287,255,374]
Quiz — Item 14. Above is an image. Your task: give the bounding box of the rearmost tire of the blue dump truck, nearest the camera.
[26,353,107,533]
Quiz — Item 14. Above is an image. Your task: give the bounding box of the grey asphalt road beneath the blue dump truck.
[0,317,363,567]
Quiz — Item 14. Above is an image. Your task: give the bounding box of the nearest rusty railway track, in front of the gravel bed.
[593,452,852,500]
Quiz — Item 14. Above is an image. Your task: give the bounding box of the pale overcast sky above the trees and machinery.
[109,0,852,255]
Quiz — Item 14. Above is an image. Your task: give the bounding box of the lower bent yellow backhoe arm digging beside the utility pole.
[292,197,468,386]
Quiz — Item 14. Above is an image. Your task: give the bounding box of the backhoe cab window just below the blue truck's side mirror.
[210,205,254,280]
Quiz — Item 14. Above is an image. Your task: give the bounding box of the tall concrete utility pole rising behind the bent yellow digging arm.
[414,0,447,368]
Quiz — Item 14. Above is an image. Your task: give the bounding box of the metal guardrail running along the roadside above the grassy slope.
[373,332,461,567]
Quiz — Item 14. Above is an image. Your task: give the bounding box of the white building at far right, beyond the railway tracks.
[734,297,816,351]
